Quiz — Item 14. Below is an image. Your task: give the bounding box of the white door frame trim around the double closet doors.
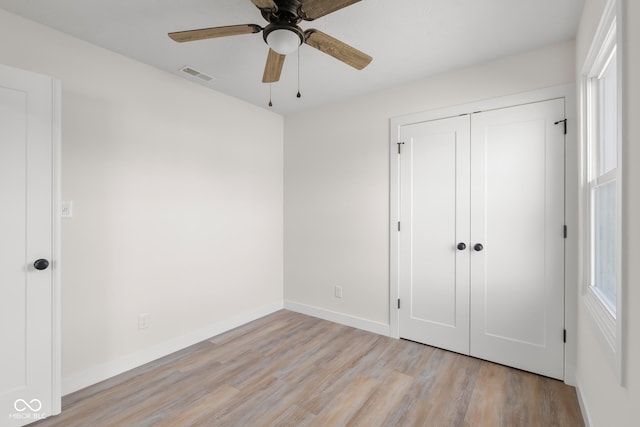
[389,84,579,385]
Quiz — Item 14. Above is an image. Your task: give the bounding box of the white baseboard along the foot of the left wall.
[62,302,283,395]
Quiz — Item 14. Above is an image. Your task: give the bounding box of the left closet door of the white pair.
[399,116,470,354]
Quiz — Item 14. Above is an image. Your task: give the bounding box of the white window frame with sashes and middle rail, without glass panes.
[580,0,625,384]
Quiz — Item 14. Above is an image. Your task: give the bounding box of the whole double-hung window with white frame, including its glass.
[581,0,624,383]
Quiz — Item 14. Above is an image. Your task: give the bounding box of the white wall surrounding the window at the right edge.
[576,0,640,427]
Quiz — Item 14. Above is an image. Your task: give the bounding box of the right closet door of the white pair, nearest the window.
[470,99,565,378]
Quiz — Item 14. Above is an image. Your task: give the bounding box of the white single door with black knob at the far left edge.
[0,66,55,426]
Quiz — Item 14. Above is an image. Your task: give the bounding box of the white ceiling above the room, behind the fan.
[0,0,584,114]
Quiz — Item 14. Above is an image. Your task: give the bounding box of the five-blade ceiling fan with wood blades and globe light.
[169,0,373,83]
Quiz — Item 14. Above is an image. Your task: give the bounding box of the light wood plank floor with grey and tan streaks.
[34,310,583,427]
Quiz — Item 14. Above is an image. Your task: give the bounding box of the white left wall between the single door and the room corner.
[0,10,283,392]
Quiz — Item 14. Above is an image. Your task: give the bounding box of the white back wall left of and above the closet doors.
[284,42,575,331]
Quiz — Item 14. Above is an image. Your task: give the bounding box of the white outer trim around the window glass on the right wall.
[580,0,625,385]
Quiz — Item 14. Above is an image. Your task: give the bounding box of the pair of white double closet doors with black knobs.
[399,99,564,378]
